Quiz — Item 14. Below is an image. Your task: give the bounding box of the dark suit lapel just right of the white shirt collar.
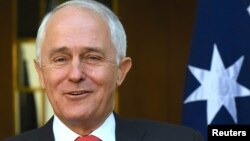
[114,113,145,141]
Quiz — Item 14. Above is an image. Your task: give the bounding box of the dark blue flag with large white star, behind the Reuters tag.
[182,0,250,139]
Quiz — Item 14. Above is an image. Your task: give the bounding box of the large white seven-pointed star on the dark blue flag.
[184,44,250,124]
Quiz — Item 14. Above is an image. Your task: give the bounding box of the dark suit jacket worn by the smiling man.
[4,114,203,141]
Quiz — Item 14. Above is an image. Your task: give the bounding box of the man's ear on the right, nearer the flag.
[116,57,132,86]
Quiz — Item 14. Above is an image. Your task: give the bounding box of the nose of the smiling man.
[69,60,85,83]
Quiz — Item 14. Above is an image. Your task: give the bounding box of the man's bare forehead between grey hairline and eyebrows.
[43,6,112,51]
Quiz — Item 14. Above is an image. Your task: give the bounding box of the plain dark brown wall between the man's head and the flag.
[119,0,195,123]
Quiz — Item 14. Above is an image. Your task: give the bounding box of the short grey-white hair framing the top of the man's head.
[36,0,127,64]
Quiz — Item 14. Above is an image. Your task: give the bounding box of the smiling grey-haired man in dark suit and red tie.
[3,0,202,141]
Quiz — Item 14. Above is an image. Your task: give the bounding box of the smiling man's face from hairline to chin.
[36,7,130,128]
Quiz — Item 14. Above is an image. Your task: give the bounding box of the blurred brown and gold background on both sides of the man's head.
[0,0,196,139]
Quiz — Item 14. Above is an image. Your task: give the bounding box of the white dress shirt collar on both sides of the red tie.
[53,113,115,141]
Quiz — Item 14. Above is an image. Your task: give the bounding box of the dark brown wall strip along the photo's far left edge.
[0,0,14,139]
